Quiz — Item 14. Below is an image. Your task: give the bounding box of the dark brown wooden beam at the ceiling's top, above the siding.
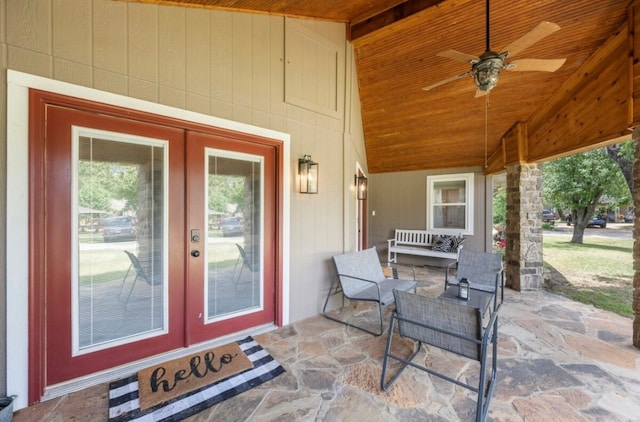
[347,0,444,41]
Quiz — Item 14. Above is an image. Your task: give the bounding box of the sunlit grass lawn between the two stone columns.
[543,233,633,318]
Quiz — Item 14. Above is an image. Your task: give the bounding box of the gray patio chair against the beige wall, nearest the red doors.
[322,247,418,336]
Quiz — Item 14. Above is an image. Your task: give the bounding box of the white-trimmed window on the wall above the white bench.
[427,173,473,235]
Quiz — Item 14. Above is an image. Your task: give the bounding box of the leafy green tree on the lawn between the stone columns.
[543,148,631,243]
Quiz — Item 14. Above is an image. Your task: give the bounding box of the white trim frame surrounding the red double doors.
[6,69,291,410]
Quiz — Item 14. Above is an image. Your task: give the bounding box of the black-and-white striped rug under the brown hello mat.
[109,337,285,422]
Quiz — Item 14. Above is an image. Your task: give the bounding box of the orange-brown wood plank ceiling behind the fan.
[125,0,630,173]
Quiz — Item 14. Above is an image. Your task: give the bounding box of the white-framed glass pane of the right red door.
[205,149,264,322]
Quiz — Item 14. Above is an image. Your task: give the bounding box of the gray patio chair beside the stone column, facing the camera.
[444,248,504,309]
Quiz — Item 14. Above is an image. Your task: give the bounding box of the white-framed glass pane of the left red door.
[72,128,168,354]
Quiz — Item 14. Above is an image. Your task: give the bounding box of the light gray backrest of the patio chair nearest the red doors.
[333,246,386,297]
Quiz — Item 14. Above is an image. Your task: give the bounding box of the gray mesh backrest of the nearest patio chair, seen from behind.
[393,290,483,361]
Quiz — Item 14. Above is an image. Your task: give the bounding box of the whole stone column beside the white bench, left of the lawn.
[505,164,543,291]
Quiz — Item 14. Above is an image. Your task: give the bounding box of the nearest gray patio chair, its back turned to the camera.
[380,290,502,421]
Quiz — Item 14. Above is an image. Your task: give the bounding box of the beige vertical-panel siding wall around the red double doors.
[0,0,366,390]
